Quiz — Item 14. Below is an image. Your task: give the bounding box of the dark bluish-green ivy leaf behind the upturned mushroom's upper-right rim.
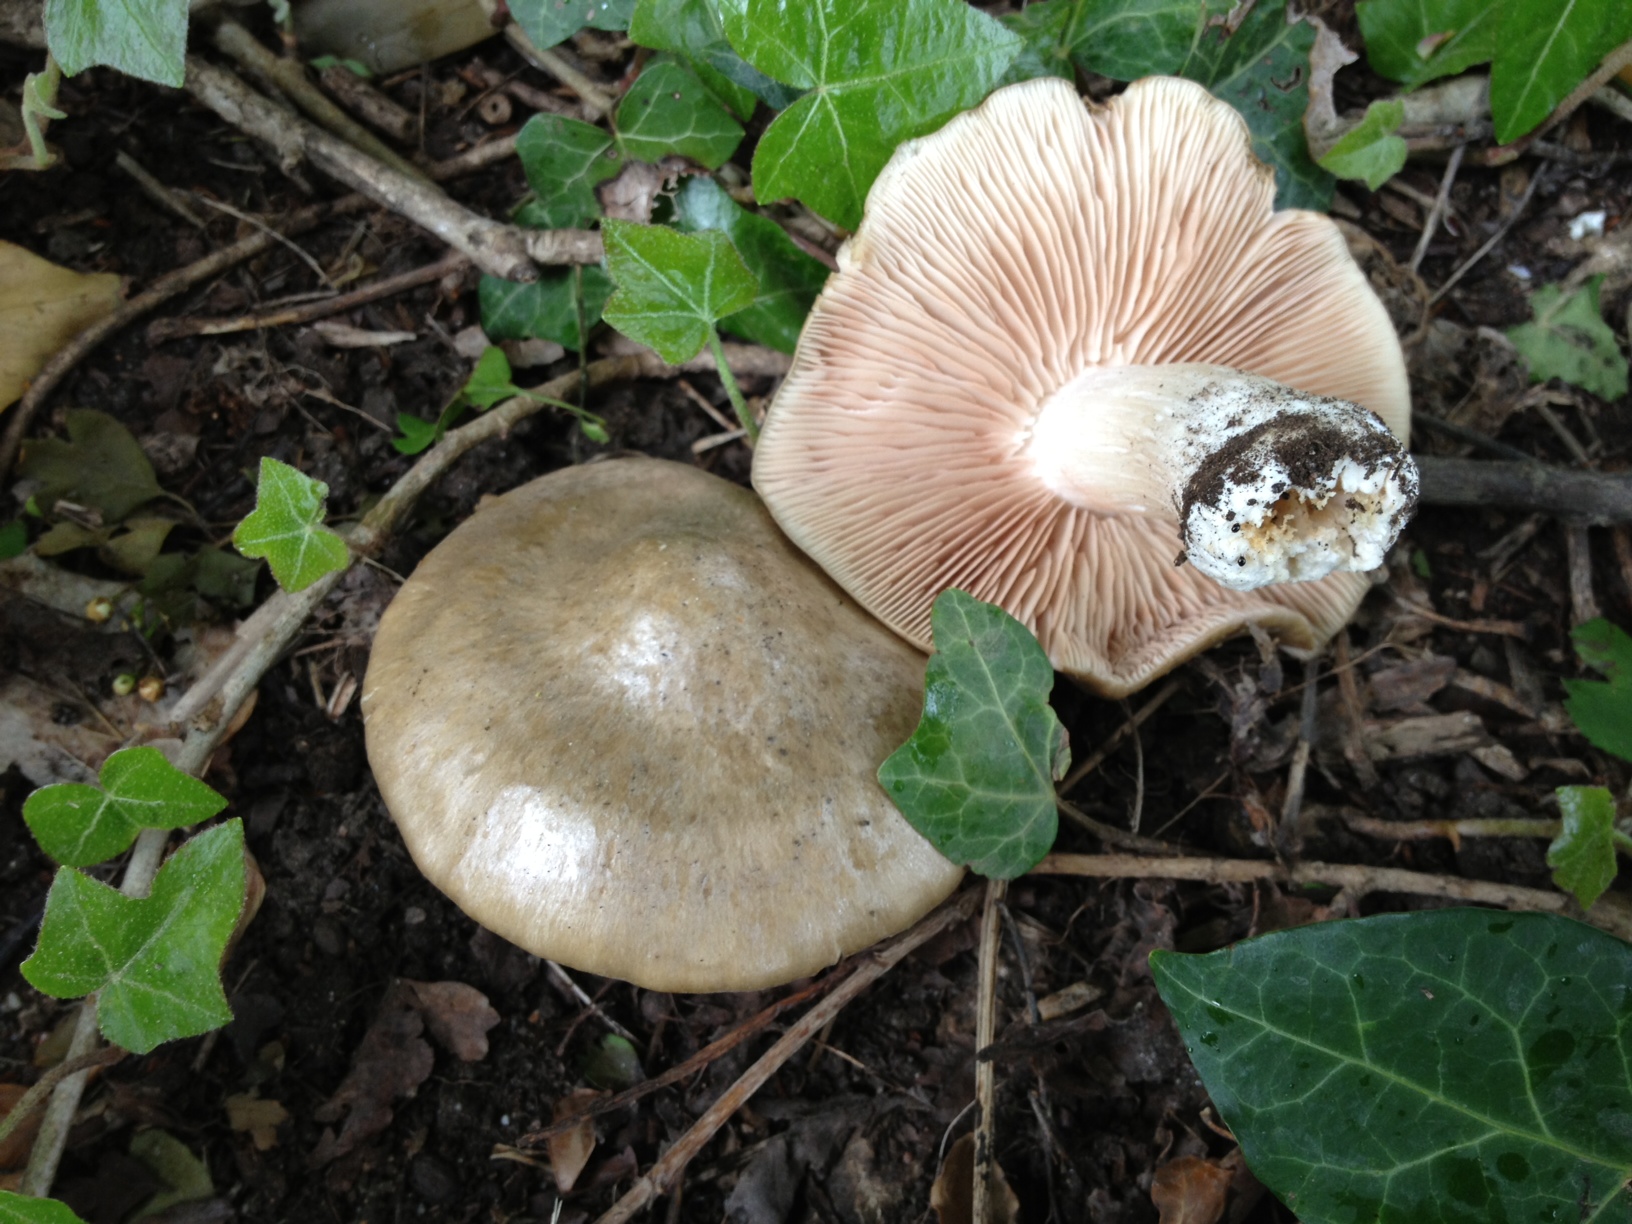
[1178,0,1332,212]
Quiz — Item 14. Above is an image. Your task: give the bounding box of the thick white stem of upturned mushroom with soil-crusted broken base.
[1023,364,1417,591]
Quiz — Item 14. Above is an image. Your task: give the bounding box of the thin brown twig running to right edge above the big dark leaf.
[1031,854,1632,938]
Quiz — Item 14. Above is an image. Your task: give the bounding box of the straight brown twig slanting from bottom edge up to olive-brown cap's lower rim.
[596,888,981,1224]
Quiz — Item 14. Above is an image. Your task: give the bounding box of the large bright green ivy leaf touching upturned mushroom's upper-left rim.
[720,0,1020,228]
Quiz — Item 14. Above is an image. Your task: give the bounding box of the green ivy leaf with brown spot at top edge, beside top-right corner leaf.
[1355,0,1501,90]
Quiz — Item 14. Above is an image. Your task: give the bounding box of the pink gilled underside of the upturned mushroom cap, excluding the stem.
[754,78,1410,695]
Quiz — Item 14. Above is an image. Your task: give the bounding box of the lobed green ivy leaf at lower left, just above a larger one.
[23,747,227,867]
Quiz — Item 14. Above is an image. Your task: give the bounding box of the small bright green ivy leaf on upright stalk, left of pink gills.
[602,220,759,364]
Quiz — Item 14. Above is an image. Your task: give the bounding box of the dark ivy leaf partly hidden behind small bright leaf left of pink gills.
[674,176,827,353]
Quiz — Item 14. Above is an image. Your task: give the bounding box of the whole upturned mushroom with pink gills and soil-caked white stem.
[754,78,1417,695]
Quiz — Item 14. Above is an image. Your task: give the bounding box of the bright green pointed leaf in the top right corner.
[1490,0,1632,144]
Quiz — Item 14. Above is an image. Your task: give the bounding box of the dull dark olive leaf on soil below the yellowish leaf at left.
[20,408,163,524]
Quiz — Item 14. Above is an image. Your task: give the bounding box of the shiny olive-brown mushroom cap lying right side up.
[362,459,961,991]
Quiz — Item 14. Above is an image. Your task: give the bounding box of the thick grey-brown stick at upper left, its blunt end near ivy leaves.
[186,55,602,281]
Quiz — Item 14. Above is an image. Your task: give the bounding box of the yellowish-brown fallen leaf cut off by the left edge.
[0,242,121,408]
